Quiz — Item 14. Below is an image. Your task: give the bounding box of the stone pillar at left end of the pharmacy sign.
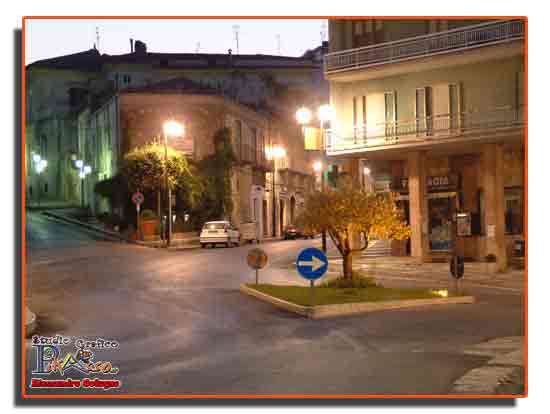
[407,151,429,261]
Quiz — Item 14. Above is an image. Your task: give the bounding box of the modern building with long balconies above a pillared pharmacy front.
[324,19,526,270]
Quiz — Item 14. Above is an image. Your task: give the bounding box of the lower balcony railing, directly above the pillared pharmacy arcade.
[325,107,524,154]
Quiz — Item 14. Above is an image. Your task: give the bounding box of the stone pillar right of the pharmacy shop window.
[482,144,508,272]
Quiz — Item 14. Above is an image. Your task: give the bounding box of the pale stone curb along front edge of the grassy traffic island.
[239,285,475,319]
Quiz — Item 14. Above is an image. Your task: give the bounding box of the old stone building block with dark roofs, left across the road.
[26,42,328,236]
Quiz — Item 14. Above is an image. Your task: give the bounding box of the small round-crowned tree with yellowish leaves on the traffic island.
[298,177,410,278]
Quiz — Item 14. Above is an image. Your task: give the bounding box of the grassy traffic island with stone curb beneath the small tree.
[240,284,475,319]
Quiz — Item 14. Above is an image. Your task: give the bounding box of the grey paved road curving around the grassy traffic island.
[27,212,523,394]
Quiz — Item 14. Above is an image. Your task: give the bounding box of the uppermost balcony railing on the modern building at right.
[324,20,524,73]
